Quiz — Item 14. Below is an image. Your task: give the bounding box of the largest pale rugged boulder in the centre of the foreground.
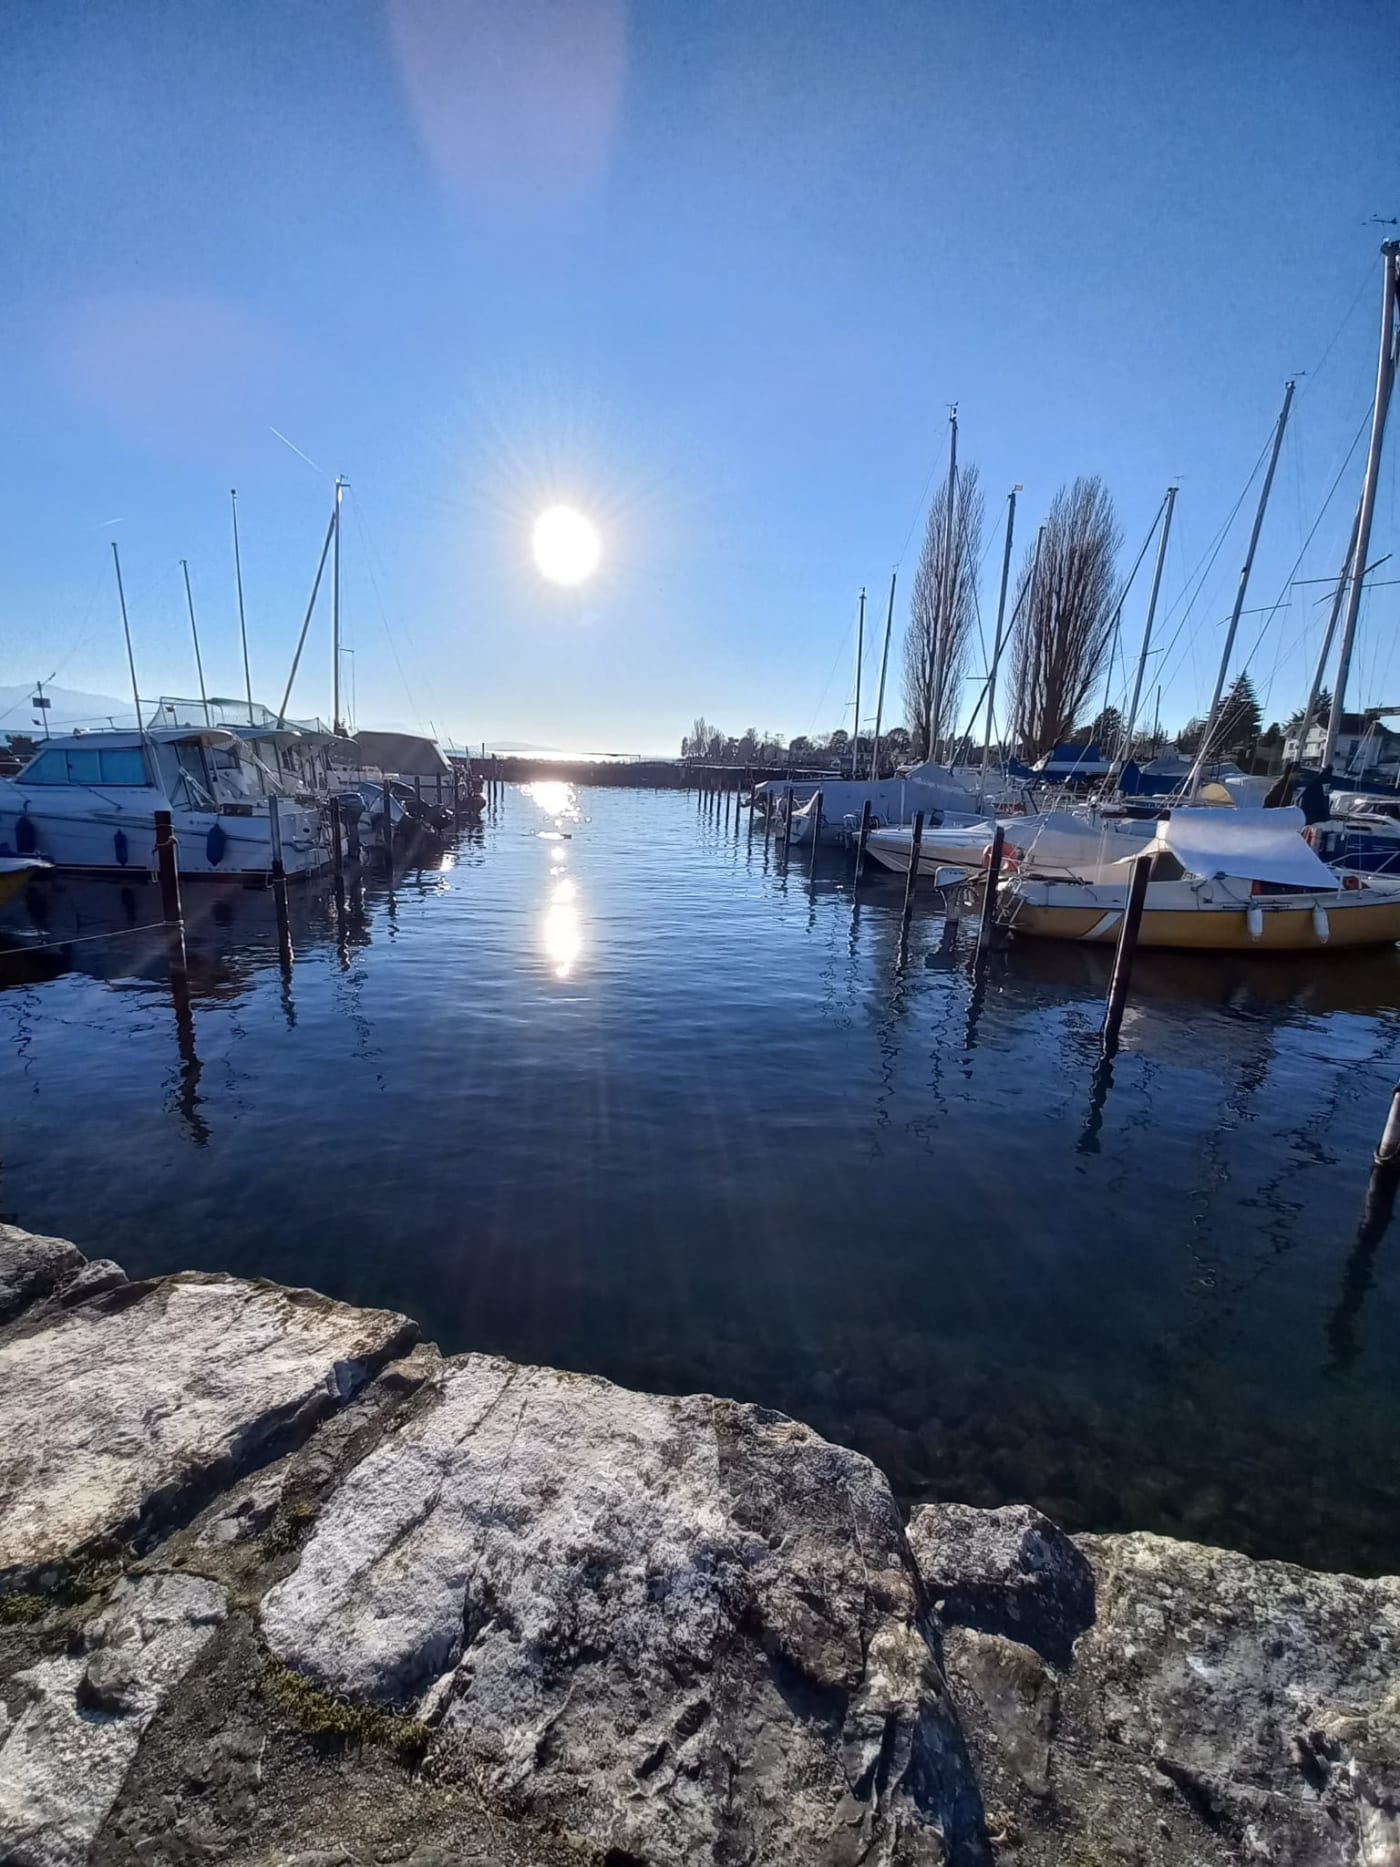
[261,1355,989,1867]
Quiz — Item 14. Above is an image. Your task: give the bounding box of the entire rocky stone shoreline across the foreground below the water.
[0,1227,1400,1867]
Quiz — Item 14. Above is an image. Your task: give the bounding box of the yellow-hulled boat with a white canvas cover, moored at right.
[999,808,1400,952]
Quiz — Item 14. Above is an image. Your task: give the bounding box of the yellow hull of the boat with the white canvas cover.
[1010,896,1400,952]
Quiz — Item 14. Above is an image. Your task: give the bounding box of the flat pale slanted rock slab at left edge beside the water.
[0,1275,414,1589]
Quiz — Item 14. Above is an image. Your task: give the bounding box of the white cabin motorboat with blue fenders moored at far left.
[0,726,330,876]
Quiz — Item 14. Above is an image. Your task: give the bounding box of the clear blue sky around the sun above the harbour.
[0,0,1400,751]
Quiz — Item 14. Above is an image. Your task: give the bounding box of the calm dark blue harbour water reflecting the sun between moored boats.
[0,788,1400,1572]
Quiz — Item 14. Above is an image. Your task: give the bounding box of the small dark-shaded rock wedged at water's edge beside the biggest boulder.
[909,1505,1094,1665]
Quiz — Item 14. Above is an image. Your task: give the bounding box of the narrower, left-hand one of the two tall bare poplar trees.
[903,467,986,756]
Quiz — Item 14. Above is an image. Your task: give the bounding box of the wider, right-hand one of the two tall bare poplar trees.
[1012,474,1122,758]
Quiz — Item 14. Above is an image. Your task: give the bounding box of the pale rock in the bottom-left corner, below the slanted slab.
[0,1576,226,1867]
